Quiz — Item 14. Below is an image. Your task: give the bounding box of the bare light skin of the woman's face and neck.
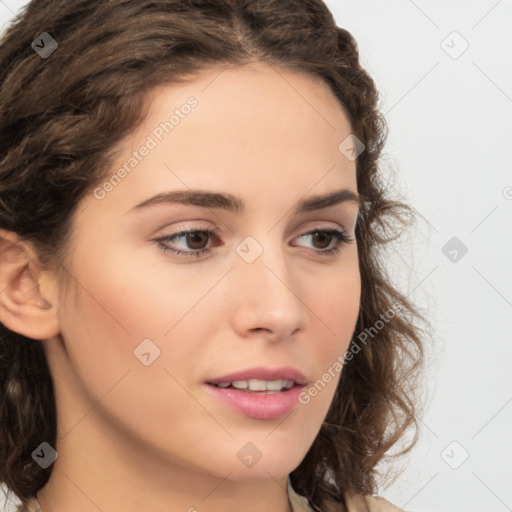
[1,63,361,512]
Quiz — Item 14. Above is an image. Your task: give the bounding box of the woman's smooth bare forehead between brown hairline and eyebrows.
[85,64,356,217]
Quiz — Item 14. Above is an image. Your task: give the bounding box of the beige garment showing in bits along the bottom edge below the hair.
[17,477,407,512]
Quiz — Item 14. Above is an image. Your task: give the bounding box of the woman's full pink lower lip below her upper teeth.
[205,384,304,420]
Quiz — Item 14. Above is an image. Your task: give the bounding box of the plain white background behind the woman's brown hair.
[0,0,512,512]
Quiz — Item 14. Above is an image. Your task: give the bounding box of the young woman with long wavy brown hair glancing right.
[0,0,423,512]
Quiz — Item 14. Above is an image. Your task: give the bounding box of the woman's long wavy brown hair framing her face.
[0,0,424,512]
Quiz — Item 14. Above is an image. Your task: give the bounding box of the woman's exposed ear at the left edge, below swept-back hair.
[0,229,60,340]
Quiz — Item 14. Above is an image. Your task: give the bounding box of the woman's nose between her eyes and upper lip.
[230,238,307,342]
